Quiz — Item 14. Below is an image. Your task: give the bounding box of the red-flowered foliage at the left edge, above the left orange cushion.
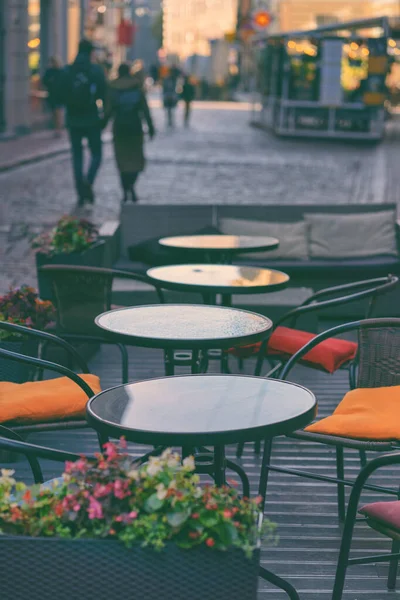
[0,285,55,340]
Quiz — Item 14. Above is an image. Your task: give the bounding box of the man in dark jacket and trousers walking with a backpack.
[63,40,106,205]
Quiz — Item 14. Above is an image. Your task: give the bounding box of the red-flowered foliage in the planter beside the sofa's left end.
[32,215,98,256]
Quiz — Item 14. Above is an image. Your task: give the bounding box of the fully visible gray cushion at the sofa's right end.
[305,211,397,259]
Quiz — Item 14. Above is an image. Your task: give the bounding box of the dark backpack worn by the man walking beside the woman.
[66,65,97,115]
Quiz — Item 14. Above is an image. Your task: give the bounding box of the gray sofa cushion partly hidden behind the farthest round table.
[218,219,308,261]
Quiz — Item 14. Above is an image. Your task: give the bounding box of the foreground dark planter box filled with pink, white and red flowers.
[0,443,273,600]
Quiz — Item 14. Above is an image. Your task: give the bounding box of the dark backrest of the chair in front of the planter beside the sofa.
[41,265,113,335]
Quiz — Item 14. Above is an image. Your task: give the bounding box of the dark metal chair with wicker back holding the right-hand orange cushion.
[260,318,400,521]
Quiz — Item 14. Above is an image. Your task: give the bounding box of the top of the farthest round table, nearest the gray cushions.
[158,235,279,253]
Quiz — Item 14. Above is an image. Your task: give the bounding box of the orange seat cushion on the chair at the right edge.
[306,385,400,441]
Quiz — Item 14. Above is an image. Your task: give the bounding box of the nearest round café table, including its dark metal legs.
[87,375,316,599]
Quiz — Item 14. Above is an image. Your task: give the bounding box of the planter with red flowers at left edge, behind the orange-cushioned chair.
[0,285,55,383]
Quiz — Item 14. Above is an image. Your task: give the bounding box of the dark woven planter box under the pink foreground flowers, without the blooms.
[0,536,260,600]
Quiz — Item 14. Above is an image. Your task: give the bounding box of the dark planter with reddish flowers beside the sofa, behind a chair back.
[32,215,104,300]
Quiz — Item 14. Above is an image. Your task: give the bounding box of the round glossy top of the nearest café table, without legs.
[88,375,316,445]
